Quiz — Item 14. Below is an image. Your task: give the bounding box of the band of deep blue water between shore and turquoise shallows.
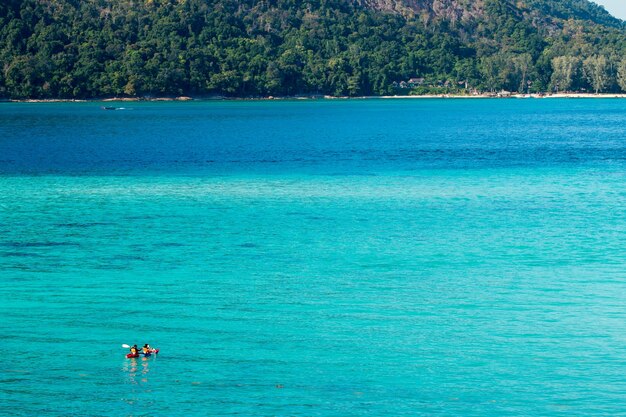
[0,100,626,175]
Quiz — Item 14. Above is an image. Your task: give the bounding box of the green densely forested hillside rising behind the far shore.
[0,0,626,98]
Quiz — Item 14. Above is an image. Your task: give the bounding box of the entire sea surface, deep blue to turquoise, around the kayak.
[0,100,626,416]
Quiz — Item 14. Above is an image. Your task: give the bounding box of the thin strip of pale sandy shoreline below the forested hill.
[0,93,626,103]
